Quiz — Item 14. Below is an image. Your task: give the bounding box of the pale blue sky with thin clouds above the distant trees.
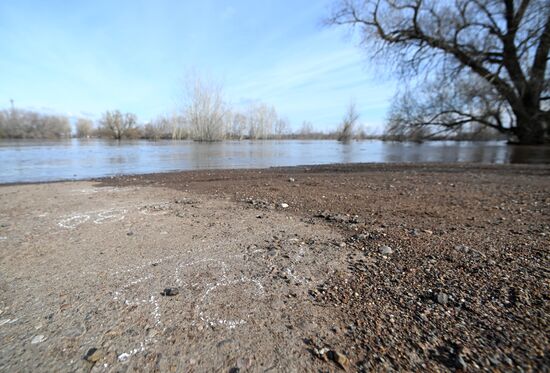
[0,0,395,130]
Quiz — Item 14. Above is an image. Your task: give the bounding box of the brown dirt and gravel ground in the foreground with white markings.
[0,165,550,372]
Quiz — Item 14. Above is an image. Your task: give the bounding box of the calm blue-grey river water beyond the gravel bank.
[0,139,550,183]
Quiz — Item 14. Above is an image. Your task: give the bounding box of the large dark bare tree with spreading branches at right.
[328,0,550,144]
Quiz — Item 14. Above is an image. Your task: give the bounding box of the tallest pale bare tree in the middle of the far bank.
[183,74,228,141]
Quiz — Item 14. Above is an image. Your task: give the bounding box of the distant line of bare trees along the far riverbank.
[0,69,505,143]
